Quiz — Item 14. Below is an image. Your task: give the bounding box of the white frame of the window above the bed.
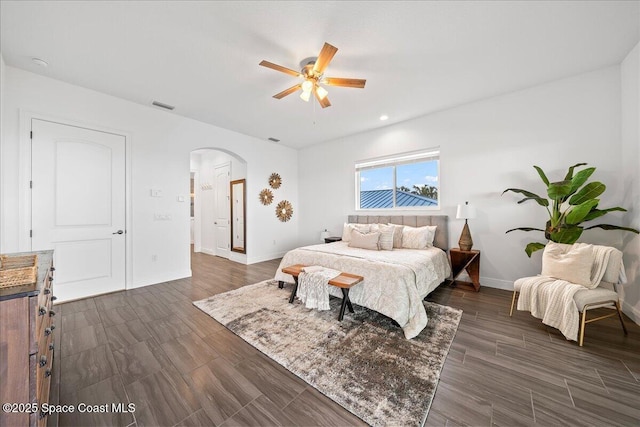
[354,147,442,212]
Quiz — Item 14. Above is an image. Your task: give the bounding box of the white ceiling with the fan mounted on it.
[0,0,640,147]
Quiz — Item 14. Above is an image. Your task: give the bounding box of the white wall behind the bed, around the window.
[299,66,623,289]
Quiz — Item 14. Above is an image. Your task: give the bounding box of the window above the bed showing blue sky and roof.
[356,149,440,209]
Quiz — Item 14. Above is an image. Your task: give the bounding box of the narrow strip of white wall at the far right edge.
[621,44,640,324]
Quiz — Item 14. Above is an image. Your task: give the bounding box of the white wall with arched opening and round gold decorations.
[0,67,298,294]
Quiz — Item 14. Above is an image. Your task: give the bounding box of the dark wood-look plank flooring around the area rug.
[49,254,640,426]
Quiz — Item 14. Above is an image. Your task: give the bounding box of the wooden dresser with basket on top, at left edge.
[0,251,55,426]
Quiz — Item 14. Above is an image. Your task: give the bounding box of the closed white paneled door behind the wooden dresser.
[31,119,126,301]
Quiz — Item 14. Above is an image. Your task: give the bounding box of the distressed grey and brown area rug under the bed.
[193,281,462,426]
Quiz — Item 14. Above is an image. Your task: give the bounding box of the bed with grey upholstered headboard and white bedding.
[275,215,451,339]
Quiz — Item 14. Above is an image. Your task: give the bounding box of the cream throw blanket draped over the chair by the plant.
[516,243,624,341]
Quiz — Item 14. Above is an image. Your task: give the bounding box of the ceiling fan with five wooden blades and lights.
[260,43,367,108]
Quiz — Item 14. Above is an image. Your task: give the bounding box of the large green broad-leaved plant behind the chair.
[502,163,640,257]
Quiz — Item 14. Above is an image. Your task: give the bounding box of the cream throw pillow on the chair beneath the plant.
[542,242,597,288]
